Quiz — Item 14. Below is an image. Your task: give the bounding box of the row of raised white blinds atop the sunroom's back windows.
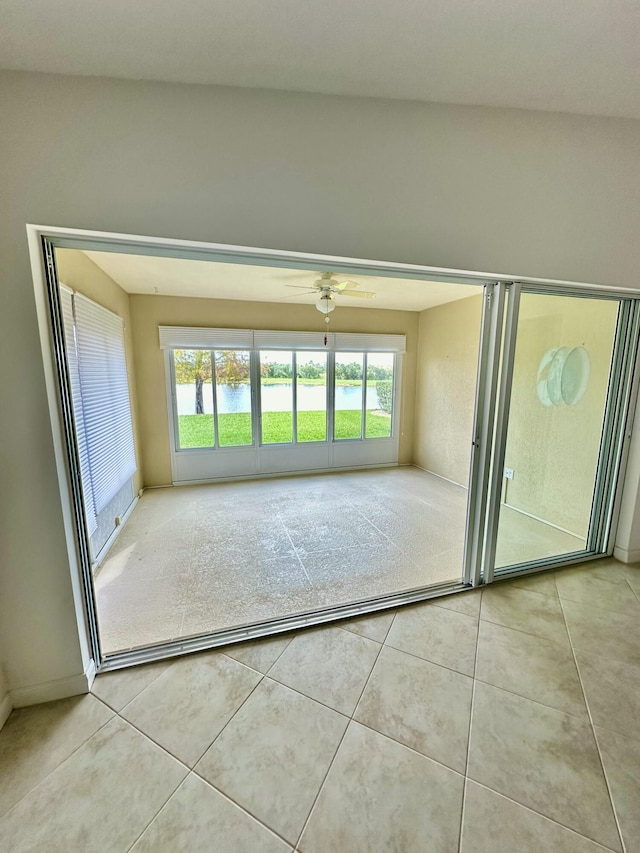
[158,326,407,352]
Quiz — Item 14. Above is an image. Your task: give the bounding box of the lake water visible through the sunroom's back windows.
[176,384,380,415]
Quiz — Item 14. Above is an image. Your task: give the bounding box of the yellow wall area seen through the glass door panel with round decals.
[504,293,617,537]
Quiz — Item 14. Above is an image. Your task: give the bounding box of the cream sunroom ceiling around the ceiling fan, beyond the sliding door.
[85,252,481,311]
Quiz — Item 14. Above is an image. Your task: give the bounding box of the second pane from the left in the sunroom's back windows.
[214,350,253,447]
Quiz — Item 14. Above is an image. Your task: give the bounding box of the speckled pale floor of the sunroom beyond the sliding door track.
[96,467,583,653]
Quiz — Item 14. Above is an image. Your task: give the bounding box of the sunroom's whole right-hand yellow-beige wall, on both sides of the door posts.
[414,294,617,536]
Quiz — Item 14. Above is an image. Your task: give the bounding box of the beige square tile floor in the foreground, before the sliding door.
[0,560,640,853]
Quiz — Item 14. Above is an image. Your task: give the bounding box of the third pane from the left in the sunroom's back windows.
[260,352,293,444]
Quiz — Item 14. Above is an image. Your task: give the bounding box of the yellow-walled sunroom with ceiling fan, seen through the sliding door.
[56,249,604,655]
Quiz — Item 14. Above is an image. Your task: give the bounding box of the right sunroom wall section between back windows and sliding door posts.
[414,292,482,486]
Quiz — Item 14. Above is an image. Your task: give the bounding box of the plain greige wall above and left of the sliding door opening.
[0,72,640,700]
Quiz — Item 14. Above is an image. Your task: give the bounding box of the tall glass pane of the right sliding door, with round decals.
[495,293,618,567]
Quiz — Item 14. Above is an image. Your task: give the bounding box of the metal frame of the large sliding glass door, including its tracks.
[27,225,640,681]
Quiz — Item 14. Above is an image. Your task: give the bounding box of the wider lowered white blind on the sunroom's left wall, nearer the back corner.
[73,294,136,513]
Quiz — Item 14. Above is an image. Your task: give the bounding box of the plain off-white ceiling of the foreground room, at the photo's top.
[0,0,640,118]
